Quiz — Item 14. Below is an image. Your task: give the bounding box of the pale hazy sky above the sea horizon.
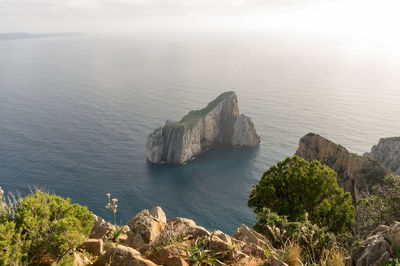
[0,0,400,38]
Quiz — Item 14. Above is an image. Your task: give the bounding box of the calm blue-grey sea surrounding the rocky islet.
[0,33,400,233]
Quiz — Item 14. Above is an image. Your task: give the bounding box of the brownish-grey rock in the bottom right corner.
[351,222,400,266]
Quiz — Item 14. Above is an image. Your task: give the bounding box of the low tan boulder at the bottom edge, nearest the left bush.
[93,245,157,266]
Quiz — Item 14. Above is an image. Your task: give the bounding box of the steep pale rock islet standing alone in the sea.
[146,91,260,164]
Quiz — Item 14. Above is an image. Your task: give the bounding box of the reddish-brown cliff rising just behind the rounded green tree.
[296,133,390,203]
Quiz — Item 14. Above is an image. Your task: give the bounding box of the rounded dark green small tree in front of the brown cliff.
[248,156,355,233]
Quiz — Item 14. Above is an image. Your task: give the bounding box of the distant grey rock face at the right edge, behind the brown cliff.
[363,137,400,174]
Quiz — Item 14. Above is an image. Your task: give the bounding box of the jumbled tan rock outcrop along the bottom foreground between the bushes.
[89,207,286,266]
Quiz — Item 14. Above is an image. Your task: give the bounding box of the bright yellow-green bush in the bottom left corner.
[0,190,94,264]
